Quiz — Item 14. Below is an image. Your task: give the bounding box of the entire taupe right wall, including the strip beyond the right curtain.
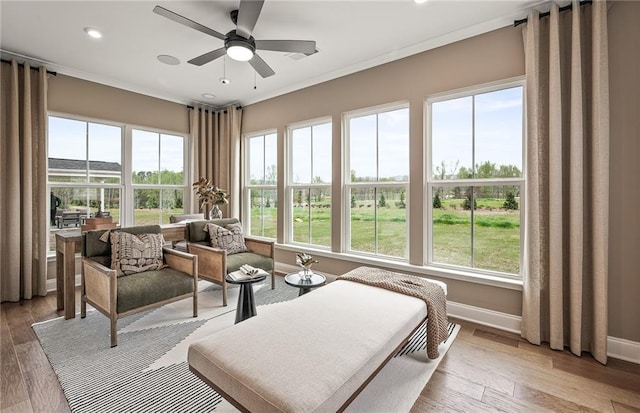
[242,2,640,342]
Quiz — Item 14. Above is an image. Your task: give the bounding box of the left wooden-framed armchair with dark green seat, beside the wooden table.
[80,225,198,347]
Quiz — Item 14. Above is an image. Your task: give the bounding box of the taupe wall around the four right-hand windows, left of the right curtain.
[242,28,524,315]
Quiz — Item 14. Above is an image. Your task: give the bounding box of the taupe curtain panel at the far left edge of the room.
[0,60,49,301]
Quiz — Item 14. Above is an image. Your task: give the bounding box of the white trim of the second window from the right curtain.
[341,100,411,262]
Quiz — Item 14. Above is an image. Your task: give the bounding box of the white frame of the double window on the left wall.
[47,111,192,257]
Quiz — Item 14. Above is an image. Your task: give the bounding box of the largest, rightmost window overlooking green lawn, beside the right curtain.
[426,82,524,276]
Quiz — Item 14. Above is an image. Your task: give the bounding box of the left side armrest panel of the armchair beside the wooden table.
[82,257,118,313]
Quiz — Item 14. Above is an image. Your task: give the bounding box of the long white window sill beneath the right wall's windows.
[276,244,522,291]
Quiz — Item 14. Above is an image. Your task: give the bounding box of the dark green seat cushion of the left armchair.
[116,268,193,313]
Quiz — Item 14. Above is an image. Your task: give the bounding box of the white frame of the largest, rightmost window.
[423,77,527,281]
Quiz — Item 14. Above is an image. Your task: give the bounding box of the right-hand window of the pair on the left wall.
[131,129,185,225]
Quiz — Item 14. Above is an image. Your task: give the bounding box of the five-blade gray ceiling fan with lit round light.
[153,0,316,78]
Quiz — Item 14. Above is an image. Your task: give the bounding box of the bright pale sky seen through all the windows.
[49,87,523,183]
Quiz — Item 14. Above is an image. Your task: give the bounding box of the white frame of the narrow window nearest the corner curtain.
[241,129,280,241]
